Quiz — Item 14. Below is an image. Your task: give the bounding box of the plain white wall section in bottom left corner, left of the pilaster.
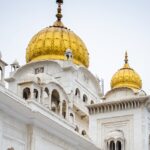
[0,112,27,150]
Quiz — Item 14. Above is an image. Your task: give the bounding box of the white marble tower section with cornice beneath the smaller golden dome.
[88,88,150,150]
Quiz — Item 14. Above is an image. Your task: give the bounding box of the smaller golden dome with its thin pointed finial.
[111,52,142,89]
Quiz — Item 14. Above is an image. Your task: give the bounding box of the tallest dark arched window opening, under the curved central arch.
[51,90,60,113]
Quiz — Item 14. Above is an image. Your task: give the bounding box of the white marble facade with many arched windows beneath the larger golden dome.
[0,57,101,150]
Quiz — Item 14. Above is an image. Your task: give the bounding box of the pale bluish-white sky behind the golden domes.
[0,0,150,93]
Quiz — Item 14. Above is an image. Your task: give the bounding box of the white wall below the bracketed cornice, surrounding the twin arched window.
[89,109,148,150]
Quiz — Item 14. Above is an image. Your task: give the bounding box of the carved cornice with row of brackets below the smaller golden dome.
[87,96,150,115]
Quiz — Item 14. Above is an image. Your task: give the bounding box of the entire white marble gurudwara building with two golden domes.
[0,0,150,150]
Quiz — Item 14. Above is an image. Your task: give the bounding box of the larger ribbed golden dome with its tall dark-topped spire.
[26,0,89,67]
